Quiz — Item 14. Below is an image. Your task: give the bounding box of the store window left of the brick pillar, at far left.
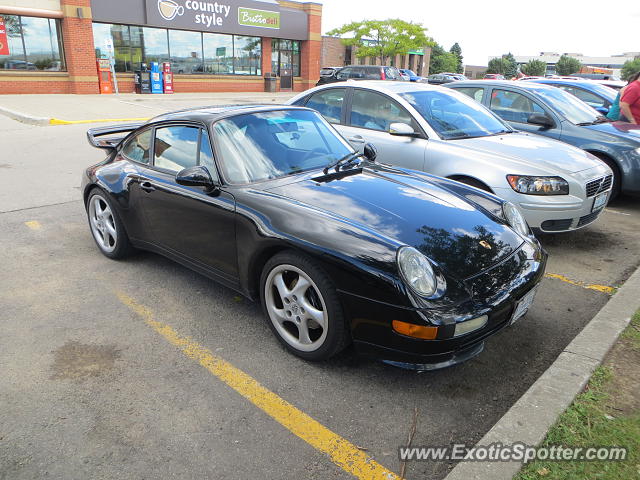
[0,15,66,71]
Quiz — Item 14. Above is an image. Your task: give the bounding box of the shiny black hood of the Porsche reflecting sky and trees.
[268,167,523,280]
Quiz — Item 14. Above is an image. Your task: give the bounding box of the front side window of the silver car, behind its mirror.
[351,89,417,132]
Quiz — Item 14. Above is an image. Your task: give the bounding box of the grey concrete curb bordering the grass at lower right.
[445,268,640,480]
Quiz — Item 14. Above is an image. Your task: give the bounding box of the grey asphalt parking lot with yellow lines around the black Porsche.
[0,117,640,479]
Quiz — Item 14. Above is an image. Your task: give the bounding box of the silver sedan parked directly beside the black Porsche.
[287,81,613,232]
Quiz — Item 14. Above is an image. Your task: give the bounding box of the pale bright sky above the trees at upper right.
[315,0,640,65]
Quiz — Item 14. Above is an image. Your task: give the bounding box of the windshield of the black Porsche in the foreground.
[213,110,353,184]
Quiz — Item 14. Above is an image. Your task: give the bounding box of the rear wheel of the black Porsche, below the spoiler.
[87,189,133,259]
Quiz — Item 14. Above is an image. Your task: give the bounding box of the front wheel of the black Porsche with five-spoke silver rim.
[260,252,349,360]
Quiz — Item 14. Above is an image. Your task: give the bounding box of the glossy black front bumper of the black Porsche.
[340,240,547,369]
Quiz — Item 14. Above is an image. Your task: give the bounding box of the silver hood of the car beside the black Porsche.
[450,132,598,174]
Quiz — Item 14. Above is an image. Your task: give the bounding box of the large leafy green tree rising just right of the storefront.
[327,19,433,65]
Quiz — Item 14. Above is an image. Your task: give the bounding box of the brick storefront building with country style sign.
[0,0,322,94]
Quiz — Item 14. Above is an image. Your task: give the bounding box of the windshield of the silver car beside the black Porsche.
[400,90,511,140]
